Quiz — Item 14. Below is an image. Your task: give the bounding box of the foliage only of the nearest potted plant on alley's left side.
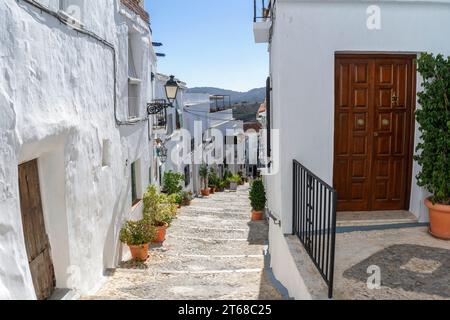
[120,220,156,246]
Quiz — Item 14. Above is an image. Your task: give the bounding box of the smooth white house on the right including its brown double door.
[254,0,450,299]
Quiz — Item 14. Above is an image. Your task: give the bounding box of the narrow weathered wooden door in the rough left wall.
[19,160,55,300]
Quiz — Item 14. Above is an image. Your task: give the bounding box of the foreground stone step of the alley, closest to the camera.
[86,270,282,300]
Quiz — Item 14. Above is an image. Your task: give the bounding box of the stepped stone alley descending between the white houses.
[84,186,283,300]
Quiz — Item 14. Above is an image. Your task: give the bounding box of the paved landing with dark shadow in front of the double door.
[335,228,450,300]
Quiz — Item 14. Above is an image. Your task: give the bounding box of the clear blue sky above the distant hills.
[145,0,269,91]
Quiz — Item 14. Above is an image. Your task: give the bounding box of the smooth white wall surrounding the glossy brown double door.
[269,0,450,233]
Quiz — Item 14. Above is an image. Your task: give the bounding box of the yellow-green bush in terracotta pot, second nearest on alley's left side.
[143,185,177,243]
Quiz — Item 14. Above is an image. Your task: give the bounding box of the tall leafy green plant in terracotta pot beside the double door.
[414,54,450,240]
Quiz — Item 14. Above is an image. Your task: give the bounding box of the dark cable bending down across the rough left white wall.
[16,0,148,126]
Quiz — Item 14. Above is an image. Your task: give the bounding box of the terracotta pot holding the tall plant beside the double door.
[425,199,450,240]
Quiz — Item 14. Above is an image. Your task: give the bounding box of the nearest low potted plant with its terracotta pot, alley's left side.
[120,220,156,261]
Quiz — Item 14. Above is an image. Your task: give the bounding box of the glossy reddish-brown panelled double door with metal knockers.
[334,55,415,211]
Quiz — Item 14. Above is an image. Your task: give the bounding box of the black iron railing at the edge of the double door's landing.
[293,160,337,299]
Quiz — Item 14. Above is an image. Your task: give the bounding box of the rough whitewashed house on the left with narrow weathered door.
[0,0,156,299]
